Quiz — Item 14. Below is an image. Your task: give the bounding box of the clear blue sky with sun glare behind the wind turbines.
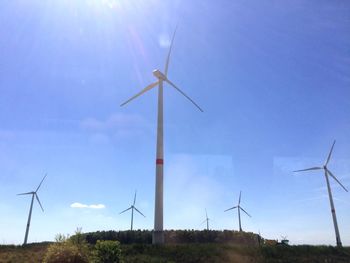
[0,0,350,248]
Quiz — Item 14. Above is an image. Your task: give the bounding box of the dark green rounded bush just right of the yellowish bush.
[93,240,122,263]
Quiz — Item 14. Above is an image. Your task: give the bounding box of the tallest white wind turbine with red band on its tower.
[120,29,203,244]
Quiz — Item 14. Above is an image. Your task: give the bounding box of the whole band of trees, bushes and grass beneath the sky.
[0,229,350,263]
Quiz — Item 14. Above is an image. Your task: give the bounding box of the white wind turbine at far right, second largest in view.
[293,140,348,247]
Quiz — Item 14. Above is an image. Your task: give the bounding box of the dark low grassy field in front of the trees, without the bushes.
[0,241,350,263]
